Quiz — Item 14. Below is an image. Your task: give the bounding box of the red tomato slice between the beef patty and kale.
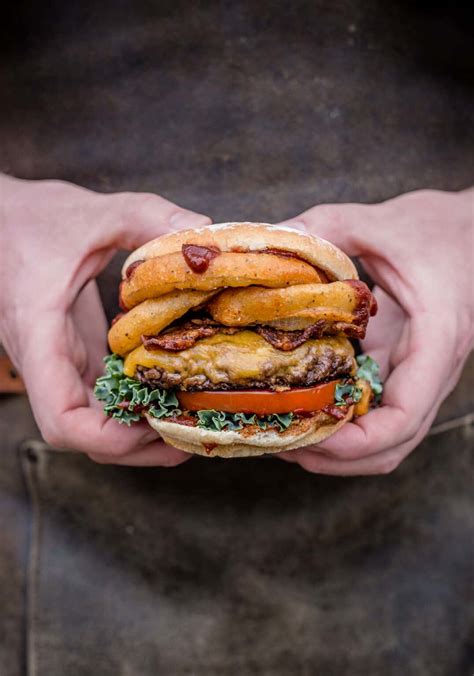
[176,380,339,415]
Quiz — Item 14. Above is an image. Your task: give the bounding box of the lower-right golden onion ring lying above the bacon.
[208,281,371,330]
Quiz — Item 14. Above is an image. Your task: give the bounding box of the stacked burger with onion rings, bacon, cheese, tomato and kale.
[95,223,382,457]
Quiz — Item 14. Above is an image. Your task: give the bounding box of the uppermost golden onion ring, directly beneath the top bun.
[120,251,321,309]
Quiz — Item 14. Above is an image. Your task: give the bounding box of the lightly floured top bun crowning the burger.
[122,223,358,280]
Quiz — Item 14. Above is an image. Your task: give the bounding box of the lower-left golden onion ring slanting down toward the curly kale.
[108,291,215,356]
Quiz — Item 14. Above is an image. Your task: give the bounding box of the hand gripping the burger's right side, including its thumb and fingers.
[280,190,474,475]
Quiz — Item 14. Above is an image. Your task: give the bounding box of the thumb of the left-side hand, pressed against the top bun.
[115,193,211,250]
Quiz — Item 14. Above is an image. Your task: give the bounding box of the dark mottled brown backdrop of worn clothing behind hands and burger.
[0,0,474,676]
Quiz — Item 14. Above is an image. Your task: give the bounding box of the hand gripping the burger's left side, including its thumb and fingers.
[0,175,210,465]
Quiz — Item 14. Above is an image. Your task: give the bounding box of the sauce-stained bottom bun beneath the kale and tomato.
[145,406,353,458]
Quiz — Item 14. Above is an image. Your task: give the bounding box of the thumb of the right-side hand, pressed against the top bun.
[279,204,373,256]
